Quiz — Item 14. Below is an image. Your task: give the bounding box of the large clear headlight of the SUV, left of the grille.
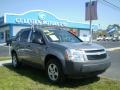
[65,49,85,62]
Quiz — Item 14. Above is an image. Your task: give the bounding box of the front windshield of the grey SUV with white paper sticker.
[43,30,82,43]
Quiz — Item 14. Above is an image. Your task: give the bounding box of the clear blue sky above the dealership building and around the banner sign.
[0,0,120,28]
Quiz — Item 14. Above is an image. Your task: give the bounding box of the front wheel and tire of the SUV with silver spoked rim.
[46,59,65,83]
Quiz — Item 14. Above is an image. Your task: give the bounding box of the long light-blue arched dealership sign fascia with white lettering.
[4,10,89,29]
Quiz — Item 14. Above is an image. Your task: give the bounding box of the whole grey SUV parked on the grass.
[11,28,111,82]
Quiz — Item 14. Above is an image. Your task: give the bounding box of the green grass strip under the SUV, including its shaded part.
[0,65,120,90]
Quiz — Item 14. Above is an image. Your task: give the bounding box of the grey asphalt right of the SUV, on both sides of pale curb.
[95,41,120,80]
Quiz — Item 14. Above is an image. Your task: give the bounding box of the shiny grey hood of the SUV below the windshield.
[55,42,104,50]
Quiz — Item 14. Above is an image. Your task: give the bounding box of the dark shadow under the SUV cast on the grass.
[4,64,100,88]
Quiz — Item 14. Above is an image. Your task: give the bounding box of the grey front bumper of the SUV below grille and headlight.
[63,60,111,77]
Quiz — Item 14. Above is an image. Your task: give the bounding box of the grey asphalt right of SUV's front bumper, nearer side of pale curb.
[102,50,120,80]
